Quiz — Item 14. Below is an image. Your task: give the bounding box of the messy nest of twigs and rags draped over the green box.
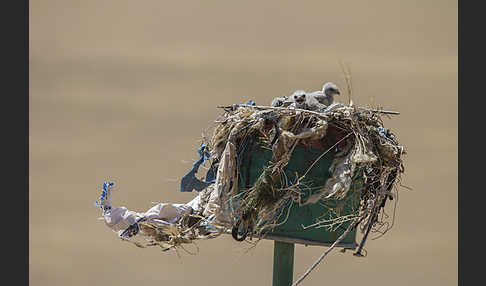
[131,103,405,254]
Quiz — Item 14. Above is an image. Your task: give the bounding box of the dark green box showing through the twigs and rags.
[238,139,361,249]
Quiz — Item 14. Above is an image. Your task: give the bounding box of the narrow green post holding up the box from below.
[272,241,294,286]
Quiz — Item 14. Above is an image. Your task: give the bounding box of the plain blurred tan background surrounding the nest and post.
[29,0,458,286]
